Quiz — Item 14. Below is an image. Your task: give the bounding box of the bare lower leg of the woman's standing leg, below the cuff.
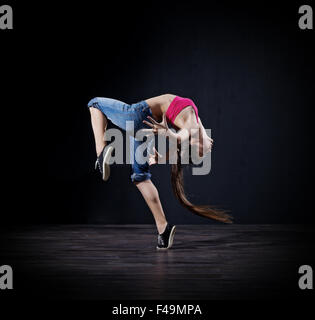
[135,179,167,234]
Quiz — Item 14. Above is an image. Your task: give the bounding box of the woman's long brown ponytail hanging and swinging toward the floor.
[171,148,232,223]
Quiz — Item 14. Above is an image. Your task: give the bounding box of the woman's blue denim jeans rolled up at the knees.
[88,98,152,182]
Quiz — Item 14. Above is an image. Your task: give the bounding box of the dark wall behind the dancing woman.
[0,1,315,224]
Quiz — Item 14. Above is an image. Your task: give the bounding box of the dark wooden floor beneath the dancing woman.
[0,225,315,300]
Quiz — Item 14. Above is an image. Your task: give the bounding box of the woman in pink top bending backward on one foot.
[88,94,231,250]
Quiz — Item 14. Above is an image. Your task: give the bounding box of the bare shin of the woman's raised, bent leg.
[89,107,107,156]
